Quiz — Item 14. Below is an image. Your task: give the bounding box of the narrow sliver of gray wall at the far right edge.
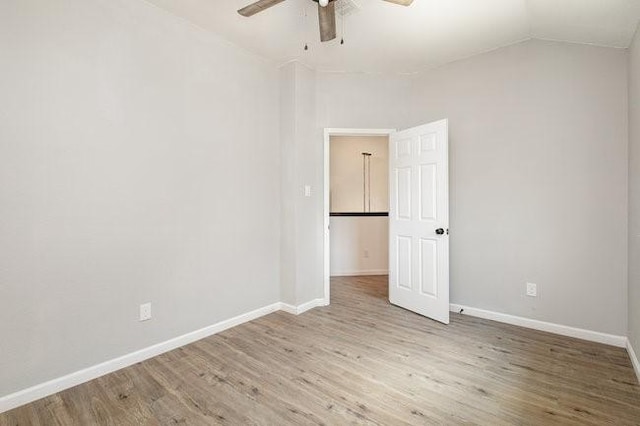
[629,25,640,354]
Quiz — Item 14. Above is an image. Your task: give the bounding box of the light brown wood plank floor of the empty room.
[0,277,640,426]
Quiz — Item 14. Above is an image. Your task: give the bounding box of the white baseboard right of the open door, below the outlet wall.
[450,304,627,348]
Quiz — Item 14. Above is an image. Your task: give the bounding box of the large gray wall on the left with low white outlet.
[0,0,280,395]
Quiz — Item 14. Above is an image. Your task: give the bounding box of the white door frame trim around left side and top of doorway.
[323,127,396,305]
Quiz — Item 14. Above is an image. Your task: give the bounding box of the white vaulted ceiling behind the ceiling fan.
[148,0,640,72]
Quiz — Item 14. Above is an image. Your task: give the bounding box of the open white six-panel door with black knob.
[389,120,449,324]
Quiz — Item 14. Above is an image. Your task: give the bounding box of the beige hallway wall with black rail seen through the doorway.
[329,134,389,299]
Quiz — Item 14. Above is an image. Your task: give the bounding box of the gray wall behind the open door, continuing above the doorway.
[306,41,628,335]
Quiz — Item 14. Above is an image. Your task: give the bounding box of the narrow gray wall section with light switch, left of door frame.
[280,62,323,305]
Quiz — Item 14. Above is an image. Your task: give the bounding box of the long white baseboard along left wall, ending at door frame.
[0,299,326,413]
